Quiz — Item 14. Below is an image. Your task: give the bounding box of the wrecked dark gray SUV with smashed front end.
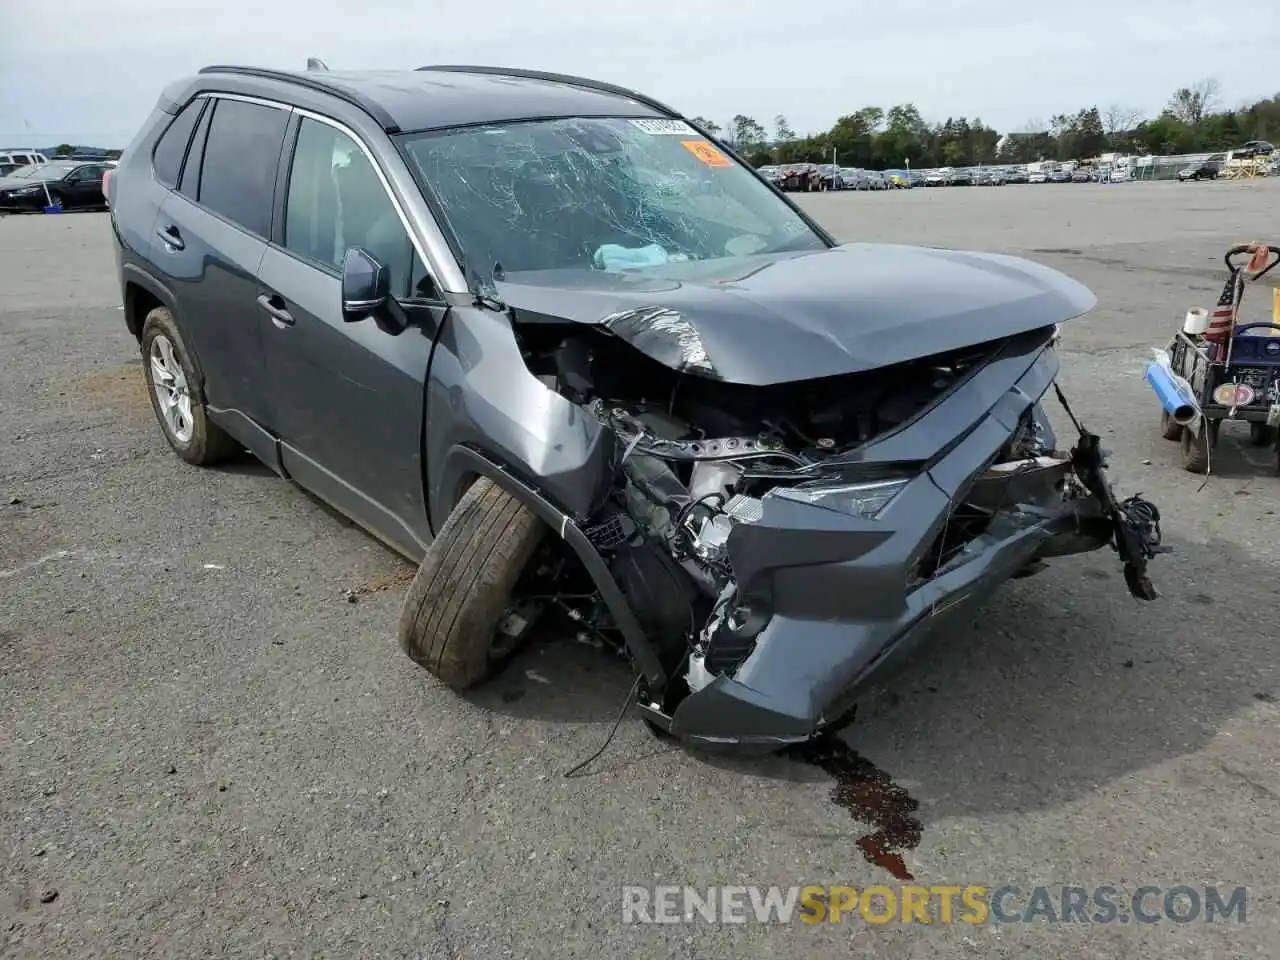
[109,67,1165,749]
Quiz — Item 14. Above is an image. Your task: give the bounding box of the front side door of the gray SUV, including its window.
[259,115,444,557]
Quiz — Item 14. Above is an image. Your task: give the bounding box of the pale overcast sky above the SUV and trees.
[0,0,1280,146]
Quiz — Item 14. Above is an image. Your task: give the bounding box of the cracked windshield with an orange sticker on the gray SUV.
[394,118,823,279]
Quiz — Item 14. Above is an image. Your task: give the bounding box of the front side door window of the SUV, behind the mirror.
[284,118,429,297]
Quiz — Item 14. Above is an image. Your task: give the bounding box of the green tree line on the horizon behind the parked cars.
[694,78,1280,170]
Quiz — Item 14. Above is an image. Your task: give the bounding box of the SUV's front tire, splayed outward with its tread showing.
[399,477,547,690]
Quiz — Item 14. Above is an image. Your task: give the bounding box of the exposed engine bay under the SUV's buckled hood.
[518,324,1160,732]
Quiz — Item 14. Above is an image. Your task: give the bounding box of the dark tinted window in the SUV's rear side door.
[200,100,289,237]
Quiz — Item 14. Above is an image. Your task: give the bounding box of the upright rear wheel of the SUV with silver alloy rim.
[140,307,243,466]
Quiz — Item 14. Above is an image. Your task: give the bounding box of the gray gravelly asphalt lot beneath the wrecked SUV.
[0,180,1280,960]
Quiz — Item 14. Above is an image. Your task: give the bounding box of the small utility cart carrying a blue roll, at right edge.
[1146,243,1280,474]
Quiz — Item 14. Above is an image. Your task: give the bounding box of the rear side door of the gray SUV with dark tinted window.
[151,96,291,465]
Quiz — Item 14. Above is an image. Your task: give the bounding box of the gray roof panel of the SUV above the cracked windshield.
[201,65,671,133]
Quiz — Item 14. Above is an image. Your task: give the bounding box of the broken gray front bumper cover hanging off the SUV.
[640,378,1166,750]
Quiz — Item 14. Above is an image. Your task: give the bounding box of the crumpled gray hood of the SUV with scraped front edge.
[495,243,1097,385]
